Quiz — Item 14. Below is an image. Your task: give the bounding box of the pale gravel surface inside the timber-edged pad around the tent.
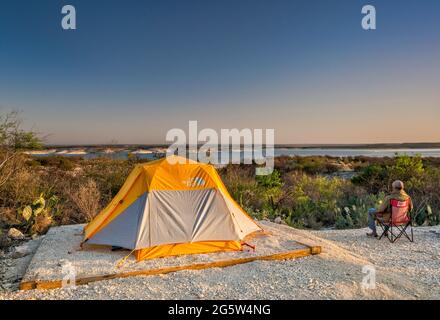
[18,225,306,281]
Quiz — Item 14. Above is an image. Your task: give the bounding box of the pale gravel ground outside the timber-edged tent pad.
[0,222,440,300]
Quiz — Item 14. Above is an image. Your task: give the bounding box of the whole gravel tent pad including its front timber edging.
[20,225,321,290]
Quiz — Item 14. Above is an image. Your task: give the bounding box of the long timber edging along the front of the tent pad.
[20,246,321,290]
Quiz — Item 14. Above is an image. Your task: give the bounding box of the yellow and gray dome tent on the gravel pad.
[83,156,261,260]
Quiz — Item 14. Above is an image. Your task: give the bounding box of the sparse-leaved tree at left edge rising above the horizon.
[0,111,42,187]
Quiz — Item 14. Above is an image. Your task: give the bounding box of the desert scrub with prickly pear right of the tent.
[225,156,440,229]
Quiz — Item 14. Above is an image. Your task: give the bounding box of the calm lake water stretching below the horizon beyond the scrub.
[35,148,440,159]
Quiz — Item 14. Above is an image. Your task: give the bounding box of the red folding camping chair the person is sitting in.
[376,199,414,243]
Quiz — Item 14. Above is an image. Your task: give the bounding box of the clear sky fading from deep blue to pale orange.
[0,0,440,144]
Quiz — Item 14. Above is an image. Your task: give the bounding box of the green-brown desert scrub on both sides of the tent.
[0,114,440,242]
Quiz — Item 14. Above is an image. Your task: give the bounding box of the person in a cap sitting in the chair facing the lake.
[367,180,413,237]
